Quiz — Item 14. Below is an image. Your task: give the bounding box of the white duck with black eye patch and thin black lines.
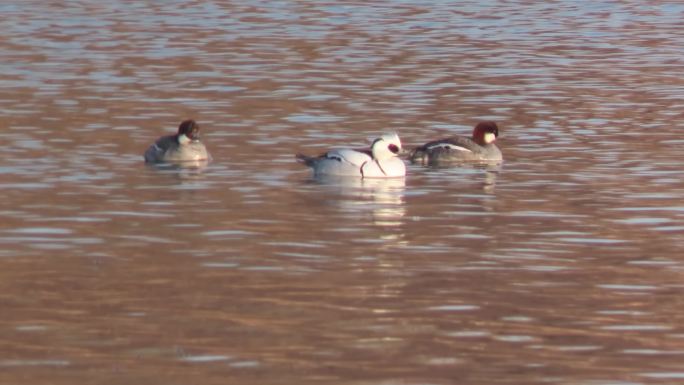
[296,132,406,178]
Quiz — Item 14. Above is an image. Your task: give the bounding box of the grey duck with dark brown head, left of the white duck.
[145,119,211,163]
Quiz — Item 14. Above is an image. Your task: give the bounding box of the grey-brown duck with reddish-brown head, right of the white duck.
[409,121,503,165]
